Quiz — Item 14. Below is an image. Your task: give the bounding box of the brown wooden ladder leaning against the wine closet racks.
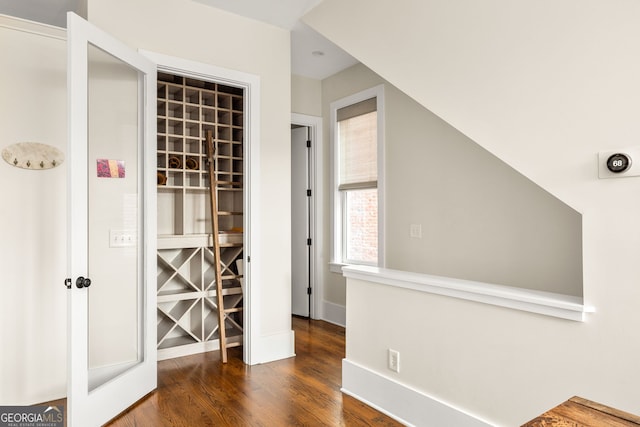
[206,130,240,363]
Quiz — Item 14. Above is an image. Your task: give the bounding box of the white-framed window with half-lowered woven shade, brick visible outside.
[331,86,383,271]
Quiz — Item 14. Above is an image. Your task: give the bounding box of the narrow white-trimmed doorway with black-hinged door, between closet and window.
[291,114,322,319]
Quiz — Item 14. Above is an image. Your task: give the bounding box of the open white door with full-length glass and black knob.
[67,13,157,427]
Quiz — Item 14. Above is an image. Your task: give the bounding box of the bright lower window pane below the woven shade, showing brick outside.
[345,188,378,264]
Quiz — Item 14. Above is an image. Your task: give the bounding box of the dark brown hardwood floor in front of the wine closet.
[94,317,401,427]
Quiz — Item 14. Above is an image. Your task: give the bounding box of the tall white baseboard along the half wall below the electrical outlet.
[342,359,492,427]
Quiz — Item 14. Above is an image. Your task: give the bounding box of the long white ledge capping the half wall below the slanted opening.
[342,265,595,322]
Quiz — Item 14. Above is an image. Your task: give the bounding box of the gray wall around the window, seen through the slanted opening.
[322,65,582,304]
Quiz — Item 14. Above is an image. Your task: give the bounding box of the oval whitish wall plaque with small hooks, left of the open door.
[2,142,64,170]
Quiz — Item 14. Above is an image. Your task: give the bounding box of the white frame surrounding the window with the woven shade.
[329,85,385,273]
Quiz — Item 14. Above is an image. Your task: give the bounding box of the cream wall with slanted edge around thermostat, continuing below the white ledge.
[305,0,640,425]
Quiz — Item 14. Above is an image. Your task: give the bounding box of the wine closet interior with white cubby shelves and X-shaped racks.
[157,72,245,360]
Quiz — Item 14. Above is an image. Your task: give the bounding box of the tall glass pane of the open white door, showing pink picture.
[87,45,143,390]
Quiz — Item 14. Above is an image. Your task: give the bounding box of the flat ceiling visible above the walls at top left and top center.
[0,0,357,80]
